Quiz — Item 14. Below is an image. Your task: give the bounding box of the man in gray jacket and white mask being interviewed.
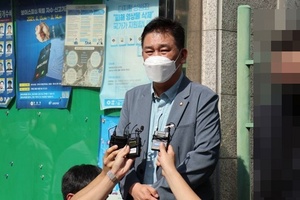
[117,18,221,200]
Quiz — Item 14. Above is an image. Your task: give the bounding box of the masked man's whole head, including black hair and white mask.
[141,17,187,86]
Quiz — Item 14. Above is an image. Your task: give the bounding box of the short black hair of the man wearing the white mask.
[141,17,185,49]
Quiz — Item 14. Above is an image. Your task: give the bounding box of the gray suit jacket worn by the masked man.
[117,76,221,200]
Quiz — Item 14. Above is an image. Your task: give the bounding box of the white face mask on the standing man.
[144,51,181,83]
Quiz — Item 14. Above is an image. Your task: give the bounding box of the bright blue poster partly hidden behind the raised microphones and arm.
[98,115,120,196]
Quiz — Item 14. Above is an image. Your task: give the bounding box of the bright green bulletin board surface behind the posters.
[0,0,119,200]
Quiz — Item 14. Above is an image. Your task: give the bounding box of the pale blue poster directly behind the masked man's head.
[100,0,159,110]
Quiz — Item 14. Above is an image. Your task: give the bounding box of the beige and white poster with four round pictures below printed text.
[62,4,106,87]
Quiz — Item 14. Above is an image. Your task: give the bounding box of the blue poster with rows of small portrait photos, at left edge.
[0,2,15,108]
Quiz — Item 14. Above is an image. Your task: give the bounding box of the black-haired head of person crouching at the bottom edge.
[61,164,102,200]
